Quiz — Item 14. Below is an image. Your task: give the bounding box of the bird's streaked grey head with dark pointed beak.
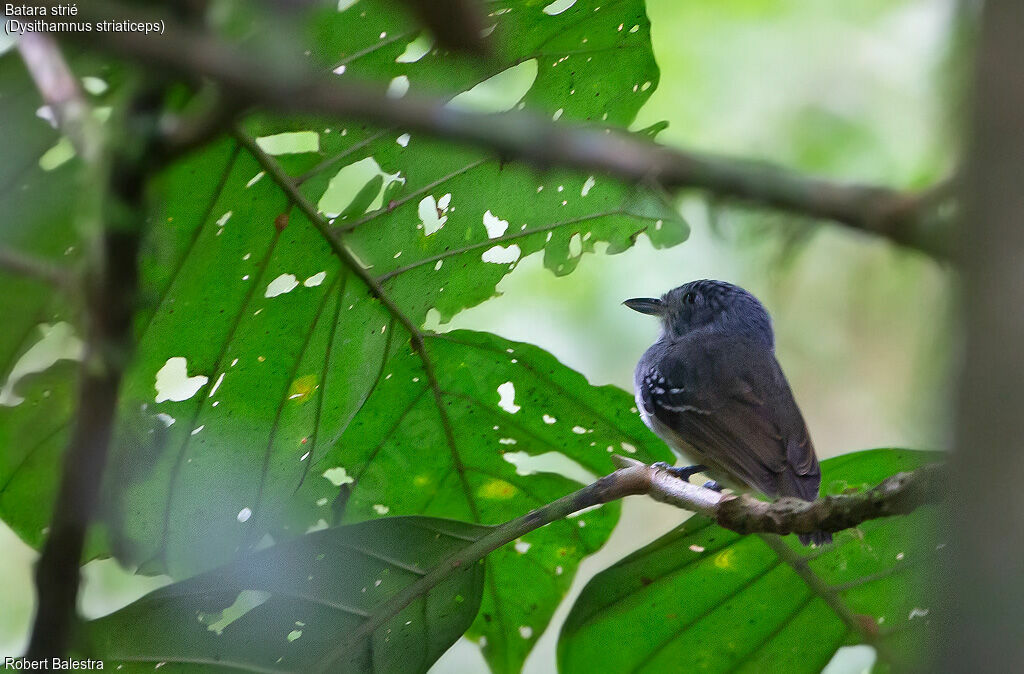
[623,279,775,348]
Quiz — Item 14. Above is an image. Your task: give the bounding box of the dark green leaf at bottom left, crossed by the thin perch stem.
[80,517,487,672]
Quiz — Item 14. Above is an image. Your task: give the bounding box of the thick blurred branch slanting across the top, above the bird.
[56,0,950,258]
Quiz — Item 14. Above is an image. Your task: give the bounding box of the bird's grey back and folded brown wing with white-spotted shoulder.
[637,339,820,500]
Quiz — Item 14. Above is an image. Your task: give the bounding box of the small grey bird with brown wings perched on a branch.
[623,279,831,545]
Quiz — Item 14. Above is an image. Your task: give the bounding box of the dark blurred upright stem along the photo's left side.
[27,81,163,662]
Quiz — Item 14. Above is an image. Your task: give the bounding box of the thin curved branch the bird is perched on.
[314,456,944,672]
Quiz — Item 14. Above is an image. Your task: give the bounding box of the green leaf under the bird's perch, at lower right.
[558,450,943,674]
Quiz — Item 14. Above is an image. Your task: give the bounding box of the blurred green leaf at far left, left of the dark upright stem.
[0,50,81,545]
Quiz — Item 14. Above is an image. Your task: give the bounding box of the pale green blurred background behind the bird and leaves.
[0,0,970,673]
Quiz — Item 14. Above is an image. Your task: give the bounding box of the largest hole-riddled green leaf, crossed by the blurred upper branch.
[92,0,685,576]
